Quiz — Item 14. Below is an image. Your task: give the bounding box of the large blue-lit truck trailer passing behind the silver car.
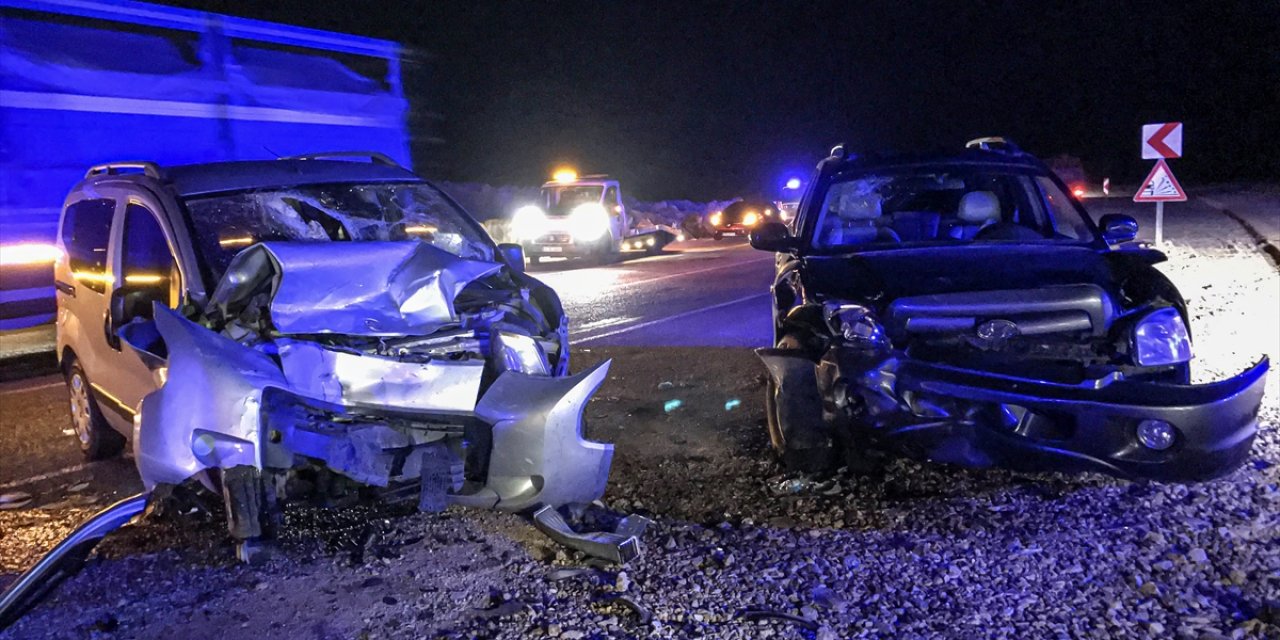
[0,0,411,330]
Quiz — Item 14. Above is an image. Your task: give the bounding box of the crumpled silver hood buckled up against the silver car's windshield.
[210,241,502,335]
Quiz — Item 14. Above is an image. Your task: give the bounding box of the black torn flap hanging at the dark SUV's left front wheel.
[755,348,832,466]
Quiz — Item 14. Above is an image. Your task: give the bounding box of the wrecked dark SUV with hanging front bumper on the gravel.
[751,138,1268,481]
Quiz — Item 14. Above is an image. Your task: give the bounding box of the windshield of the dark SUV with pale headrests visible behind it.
[813,166,1093,251]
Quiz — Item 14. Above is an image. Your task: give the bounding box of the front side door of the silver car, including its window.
[104,196,184,424]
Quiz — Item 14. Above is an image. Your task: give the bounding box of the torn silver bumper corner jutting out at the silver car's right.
[476,361,613,511]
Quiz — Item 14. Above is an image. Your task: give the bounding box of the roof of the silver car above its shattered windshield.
[164,159,421,196]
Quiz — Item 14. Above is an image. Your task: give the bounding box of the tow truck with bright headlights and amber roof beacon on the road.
[511,169,677,262]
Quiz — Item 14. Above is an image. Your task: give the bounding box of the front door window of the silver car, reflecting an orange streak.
[122,202,182,319]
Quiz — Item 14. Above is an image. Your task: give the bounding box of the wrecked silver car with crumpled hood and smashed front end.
[55,154,613,550]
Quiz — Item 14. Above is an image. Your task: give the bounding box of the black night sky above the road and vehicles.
[170,0,1280,200]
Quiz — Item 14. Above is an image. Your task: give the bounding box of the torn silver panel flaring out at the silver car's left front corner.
[133,307,288,490]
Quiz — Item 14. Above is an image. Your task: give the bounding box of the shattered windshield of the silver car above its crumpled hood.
[186,183,493,282]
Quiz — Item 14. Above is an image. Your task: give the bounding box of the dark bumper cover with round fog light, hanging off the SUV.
[874,358,1268,481]
